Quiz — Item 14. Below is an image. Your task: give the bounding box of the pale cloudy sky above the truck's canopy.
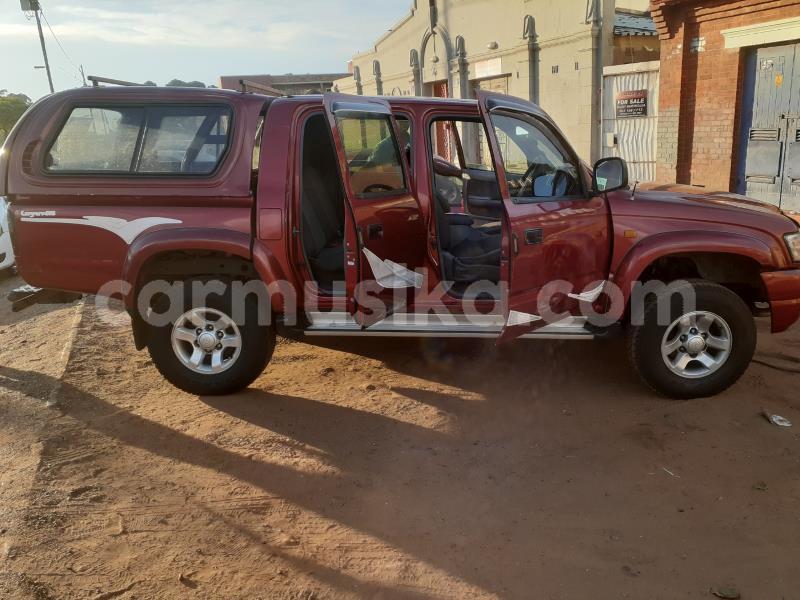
[0,0,411,100]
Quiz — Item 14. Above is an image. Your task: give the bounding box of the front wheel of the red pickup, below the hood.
[628,281,756,400]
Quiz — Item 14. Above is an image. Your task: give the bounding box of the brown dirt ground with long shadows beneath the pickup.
[0,279,800,600]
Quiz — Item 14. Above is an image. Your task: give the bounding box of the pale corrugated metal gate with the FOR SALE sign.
[602,61,659,182]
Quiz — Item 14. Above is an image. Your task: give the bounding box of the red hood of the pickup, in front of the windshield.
[610,185,797,235]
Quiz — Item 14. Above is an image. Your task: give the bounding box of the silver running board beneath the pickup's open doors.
[303,312,595,340]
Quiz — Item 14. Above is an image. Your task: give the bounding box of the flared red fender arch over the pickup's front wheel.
[609,231,786,303]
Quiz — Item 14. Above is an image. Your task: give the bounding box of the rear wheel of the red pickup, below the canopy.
[147,284,275,396]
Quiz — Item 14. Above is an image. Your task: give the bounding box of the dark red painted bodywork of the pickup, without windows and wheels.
[0,88,800,331]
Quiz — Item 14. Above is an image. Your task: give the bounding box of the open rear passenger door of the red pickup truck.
[324,94,427,327]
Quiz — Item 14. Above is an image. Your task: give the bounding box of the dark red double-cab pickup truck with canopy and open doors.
[0,87,800,398]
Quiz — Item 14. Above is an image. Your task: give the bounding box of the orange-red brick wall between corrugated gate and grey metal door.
[651,0,800,190]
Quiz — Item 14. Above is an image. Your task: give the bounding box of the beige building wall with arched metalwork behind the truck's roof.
[335,0,620,160]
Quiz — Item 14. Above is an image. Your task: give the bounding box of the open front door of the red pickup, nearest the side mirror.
[478,92,611,343]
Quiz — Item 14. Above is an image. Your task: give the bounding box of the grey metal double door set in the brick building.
[740,44,800,211]
